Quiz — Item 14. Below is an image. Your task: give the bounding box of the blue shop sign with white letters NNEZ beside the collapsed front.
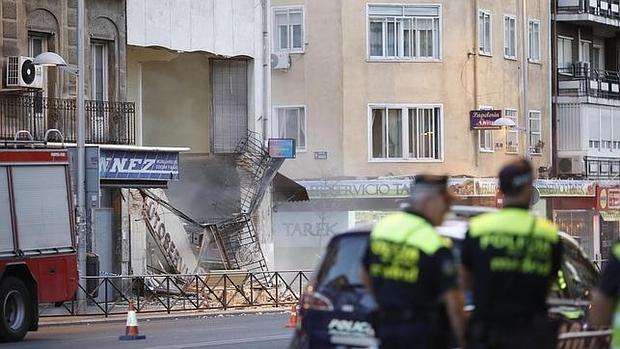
[99,149,179,181]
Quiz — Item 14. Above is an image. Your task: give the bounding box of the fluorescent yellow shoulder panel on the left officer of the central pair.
[370,212,451,255]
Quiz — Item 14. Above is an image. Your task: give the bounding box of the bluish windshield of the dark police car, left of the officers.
[317,235,368,289]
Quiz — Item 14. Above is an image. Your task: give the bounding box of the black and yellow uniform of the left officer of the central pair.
[363,212,457,349]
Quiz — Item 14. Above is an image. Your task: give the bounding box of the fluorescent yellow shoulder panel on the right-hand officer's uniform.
[469,208,559,243]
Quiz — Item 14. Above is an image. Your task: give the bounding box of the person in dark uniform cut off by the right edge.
[590,243,620,349]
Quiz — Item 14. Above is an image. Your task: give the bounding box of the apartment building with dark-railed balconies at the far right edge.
[552,0,620,261]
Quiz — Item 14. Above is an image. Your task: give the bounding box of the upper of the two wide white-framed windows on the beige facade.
[368,5,441,60]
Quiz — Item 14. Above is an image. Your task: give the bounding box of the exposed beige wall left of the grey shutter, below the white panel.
[128,47,211,153]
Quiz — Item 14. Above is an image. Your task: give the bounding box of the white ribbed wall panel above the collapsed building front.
[127,0,263,58]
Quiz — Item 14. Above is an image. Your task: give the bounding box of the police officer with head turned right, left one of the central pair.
[362,175,464,348]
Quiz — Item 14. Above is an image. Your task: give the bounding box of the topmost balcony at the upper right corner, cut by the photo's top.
[556,0,620,27]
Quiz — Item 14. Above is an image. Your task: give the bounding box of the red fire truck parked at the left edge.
[0,146,78,341]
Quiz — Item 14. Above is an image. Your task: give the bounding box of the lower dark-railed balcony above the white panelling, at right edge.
[558,64,620,105]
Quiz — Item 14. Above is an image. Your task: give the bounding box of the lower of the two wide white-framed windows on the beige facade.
[370,105,443,160]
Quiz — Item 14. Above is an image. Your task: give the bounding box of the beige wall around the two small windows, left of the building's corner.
[271,0,344,178]
